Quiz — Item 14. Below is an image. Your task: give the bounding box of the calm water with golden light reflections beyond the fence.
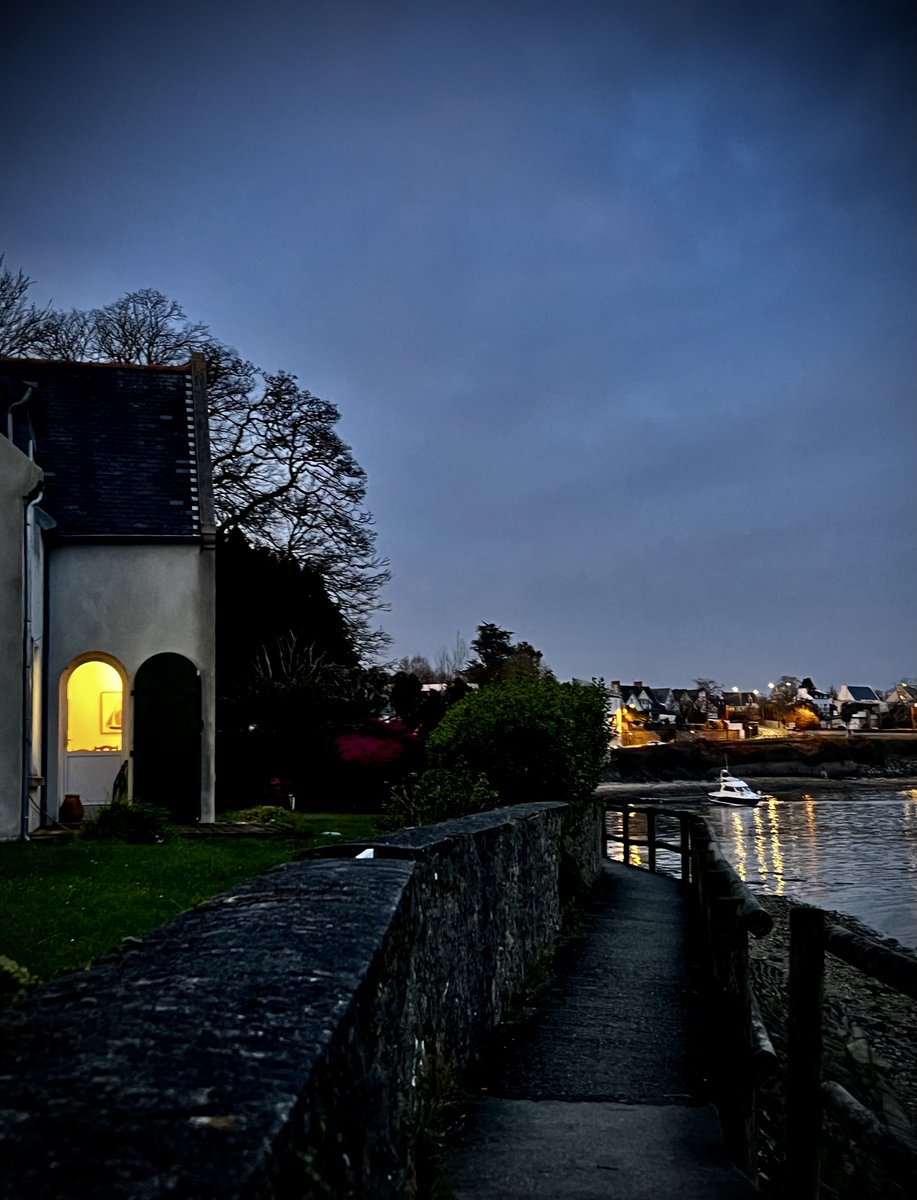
[611,785,917,948]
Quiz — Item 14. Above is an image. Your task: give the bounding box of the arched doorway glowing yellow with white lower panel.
[61,658,124,812]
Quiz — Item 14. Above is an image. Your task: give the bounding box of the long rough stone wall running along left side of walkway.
[0,802,601,1200]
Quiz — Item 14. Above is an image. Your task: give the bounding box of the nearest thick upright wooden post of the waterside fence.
[786,907,825,1200]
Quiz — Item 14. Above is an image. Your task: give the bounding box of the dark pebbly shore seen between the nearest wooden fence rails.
[749,894,917,1200]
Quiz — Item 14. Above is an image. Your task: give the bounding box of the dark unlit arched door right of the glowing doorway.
[133,654,202,824]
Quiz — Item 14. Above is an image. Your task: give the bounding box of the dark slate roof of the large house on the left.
[0,359,200,541]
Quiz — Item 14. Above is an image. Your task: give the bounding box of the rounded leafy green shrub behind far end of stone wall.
[428,676,609,804]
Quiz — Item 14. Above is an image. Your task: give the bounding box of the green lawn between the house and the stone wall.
[0,812,376,982]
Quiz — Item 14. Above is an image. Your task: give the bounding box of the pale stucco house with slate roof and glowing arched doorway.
[0,358,215,838]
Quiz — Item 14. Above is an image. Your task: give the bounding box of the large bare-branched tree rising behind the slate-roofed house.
[0,258,389,654]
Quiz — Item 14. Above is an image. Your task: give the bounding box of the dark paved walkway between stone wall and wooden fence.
[445,863,757,1200]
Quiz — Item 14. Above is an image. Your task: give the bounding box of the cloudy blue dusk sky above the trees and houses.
[0,0,917,689]
